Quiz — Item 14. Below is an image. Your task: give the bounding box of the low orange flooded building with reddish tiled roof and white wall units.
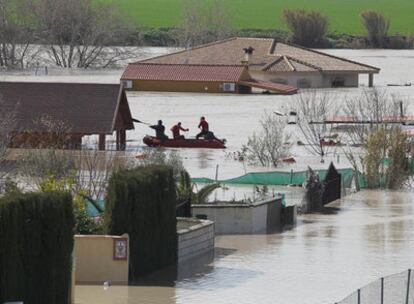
[121,62,297,94]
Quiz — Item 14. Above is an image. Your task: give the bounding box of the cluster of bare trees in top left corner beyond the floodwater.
[0,0,130,68]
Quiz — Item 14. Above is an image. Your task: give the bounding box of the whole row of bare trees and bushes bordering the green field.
[0,0,413,68]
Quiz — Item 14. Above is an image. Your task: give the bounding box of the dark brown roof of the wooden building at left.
[0,82,134,134]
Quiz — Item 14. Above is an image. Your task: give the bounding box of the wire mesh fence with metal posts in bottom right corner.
[335,269,414,304]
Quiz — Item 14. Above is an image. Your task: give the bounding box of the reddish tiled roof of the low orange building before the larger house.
[121,63,246,82]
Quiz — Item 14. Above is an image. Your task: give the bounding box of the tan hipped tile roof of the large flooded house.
[140,37,380,73]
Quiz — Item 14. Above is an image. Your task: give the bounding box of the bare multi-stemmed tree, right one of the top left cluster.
[37,0,131,68]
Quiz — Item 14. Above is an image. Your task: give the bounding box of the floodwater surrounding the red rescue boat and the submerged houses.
[0,48,414,179]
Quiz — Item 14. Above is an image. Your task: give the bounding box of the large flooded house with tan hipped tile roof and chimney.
[123,38,380,89]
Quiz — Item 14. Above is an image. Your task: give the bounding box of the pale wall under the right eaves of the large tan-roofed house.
[249,70,358,88]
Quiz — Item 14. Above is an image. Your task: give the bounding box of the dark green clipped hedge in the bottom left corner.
[0,192,74,304]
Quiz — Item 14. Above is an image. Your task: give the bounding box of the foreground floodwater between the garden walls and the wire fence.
[76,191,414,304]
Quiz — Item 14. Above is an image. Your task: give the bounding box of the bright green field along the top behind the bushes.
[100,0,414,34]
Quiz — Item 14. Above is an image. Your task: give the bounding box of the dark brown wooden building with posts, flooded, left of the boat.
[0,82,134,150]
